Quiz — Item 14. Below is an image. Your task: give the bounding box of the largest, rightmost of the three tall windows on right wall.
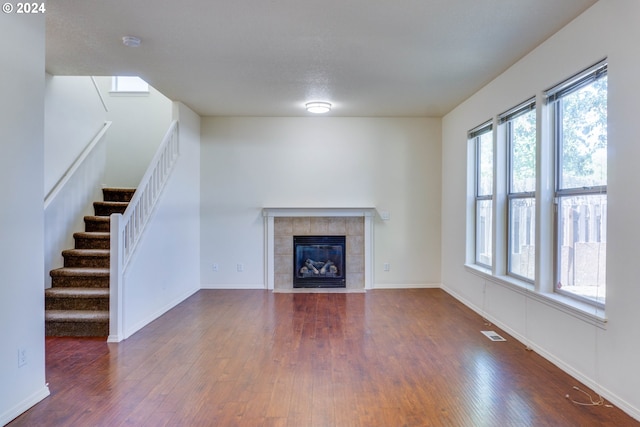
[546,62,607,305]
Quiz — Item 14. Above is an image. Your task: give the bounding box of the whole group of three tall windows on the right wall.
[467,60,608,312]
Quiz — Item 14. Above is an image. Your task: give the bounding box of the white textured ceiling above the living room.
[46,0,596,117]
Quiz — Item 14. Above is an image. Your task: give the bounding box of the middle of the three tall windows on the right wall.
[498,99,537,282]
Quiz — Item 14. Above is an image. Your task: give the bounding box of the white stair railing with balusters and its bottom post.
[108,121,180,342]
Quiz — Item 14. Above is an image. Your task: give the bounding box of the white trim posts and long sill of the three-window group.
[464,64,608,329]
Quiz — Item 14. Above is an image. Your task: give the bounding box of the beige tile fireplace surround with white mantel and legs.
[262,208,376,292]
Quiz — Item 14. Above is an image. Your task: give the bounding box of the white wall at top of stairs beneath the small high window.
[96,77,172,187]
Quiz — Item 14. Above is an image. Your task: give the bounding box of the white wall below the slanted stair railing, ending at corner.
[123,103,200,338]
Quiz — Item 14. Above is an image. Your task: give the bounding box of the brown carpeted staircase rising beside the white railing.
[45,188,135,337]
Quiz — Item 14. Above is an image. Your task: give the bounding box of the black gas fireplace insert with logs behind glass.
[293,236,346,288]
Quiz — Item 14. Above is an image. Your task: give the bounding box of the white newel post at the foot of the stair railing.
[107,214,124,342]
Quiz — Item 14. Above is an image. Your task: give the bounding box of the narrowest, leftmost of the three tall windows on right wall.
[469,123,493,268]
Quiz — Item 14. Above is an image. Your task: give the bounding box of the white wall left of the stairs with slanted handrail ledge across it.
[44,74,108,287]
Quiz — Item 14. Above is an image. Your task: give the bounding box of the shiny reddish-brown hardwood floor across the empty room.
[9,289,640,427]
